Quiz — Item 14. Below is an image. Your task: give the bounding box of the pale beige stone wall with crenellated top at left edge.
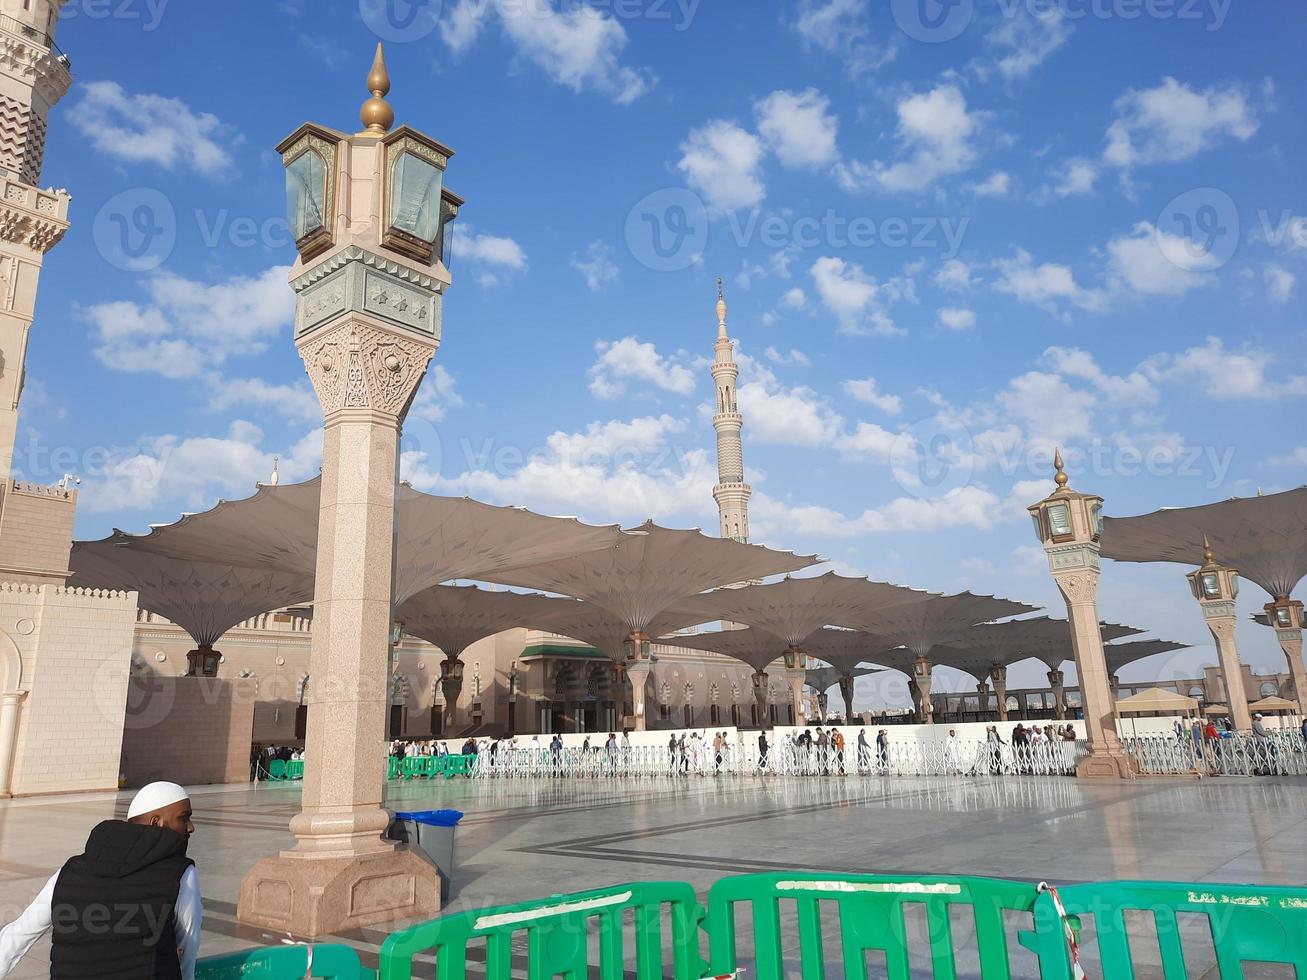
[0,583,136,796]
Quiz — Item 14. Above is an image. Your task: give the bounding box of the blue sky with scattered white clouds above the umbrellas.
[18,0,1307,695]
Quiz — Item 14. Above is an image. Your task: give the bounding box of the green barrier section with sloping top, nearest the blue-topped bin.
[379,882,703,980]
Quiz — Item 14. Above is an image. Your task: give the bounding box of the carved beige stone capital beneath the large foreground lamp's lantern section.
[299,321,435,418]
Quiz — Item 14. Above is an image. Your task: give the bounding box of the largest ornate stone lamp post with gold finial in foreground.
[238,46,461,937]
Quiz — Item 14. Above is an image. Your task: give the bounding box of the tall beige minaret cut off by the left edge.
[0,0,72,494]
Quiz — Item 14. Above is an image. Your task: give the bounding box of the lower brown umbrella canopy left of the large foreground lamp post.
[68,538,314,645]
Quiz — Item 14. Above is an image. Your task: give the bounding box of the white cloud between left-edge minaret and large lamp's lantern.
[68,81,240,176]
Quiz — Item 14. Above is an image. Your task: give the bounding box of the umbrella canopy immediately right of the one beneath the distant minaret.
[702,572,932,652]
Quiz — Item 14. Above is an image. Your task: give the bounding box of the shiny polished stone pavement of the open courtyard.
[0,776,1307,977]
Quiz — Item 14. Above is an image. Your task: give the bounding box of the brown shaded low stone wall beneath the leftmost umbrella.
[122,677,255,788]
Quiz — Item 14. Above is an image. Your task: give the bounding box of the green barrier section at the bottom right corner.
[1029,881,1307,980]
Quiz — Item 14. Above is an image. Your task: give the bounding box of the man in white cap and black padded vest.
[0,783,201,980]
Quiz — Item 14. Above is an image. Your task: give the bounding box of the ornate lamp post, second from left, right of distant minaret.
[1027,451,1132,777]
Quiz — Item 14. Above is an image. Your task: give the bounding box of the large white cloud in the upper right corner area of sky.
[1103,77,1259,167]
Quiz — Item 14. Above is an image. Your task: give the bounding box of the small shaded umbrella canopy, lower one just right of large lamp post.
[395,585,574,657]
